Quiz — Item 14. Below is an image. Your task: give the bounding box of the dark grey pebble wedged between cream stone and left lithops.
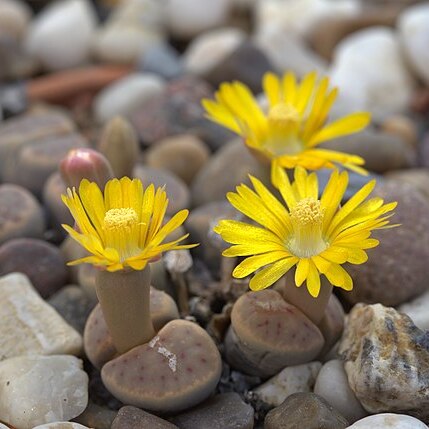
[48,285,97,334]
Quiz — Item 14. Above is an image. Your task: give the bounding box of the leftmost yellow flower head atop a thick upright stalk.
[62,177,196,271]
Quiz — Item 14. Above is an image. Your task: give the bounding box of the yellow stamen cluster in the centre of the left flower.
[103,207,141,262]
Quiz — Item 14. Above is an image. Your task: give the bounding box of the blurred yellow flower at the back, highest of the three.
[203,72,370,182]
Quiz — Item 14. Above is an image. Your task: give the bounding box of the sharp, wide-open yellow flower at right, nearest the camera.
[214,167,396,297]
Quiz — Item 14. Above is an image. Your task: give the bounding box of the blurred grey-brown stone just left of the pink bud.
[3,133,88,196]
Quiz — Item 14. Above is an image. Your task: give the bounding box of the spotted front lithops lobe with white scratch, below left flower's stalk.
[101,320,222,412]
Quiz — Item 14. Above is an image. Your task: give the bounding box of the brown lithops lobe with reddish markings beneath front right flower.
[225,290,324,377]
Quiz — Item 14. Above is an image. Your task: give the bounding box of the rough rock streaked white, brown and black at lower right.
[339,304,429,421]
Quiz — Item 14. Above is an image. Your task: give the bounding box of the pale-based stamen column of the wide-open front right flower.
[288,197,328,258]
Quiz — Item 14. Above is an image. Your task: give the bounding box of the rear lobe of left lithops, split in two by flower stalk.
[83,287,179,369]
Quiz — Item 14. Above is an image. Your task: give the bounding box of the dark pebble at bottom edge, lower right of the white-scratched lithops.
[171,392,254,429]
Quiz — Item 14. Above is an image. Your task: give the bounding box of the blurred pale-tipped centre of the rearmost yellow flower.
[265,103,302,156]
